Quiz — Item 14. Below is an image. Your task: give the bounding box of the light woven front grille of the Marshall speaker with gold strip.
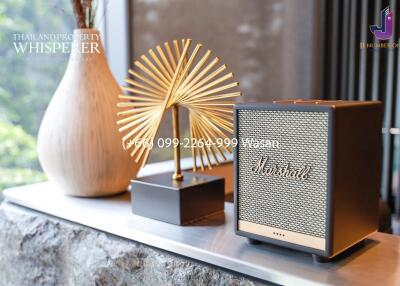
[236,109,329,251]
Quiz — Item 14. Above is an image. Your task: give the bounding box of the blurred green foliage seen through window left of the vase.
[0,0,74,190]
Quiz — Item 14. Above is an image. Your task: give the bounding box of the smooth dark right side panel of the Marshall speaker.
[332,104,382,255]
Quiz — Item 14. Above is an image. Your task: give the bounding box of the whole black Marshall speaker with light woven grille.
[235,100,382,261]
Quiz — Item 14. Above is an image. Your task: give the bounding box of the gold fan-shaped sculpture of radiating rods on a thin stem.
[117,39,241,180]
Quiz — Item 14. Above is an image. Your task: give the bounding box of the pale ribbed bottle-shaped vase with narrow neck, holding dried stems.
[38,29,139,197]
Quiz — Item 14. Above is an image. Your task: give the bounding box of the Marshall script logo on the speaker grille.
[251,156,311,181]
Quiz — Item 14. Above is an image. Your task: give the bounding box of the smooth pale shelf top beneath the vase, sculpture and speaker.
[3,182,400,285]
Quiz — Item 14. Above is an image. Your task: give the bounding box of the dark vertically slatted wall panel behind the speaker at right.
[320,0,400,214]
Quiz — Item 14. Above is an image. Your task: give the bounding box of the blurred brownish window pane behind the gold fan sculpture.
[131,0,315,161]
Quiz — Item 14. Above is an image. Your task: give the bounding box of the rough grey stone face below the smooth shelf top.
[0,202,266,286]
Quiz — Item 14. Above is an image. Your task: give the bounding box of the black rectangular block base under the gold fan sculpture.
[131,172,225,225]
